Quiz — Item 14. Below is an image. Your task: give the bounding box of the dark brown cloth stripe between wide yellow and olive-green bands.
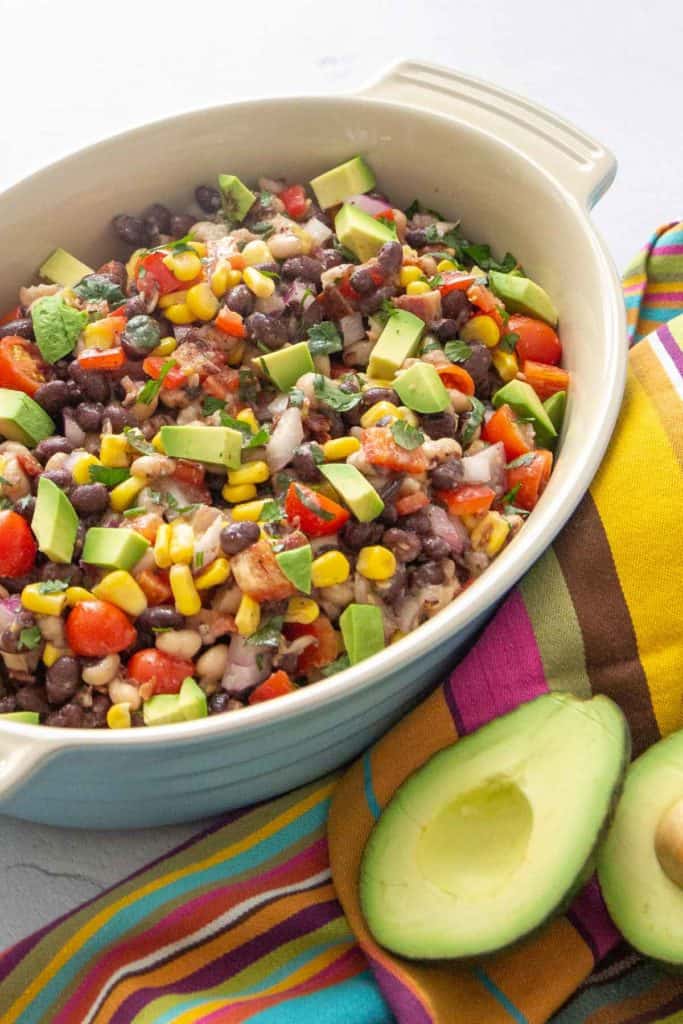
[555,494,659,754]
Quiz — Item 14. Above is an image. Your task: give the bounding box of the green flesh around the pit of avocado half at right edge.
[598,730,683,968]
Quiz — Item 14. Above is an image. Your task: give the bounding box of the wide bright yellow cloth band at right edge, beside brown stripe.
[591,364,683,733]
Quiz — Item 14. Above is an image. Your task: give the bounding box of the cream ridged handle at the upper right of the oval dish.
[360,60,616,209]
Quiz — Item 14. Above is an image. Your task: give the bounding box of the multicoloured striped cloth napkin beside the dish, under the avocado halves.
[0,223,683,1024]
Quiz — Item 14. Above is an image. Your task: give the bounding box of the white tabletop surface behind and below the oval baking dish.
[0,0,683,946]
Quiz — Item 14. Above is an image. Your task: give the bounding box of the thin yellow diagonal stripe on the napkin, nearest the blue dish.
[2,779,336,1024]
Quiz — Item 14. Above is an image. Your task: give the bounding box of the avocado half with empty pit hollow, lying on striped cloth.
[360,694,629,958]
